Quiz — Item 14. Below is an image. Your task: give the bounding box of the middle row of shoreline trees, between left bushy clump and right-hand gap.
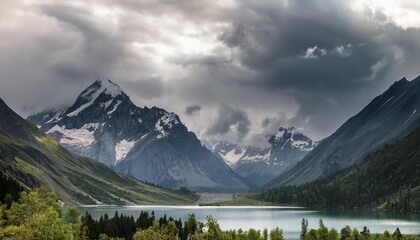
[81,211,284,240]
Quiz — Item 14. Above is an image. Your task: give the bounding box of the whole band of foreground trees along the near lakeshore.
[0,189,420,240]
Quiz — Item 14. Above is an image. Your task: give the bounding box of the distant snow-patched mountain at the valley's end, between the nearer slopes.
[205,127,317,186]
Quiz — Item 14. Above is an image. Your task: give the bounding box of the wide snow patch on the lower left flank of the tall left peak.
[47,123,99,147]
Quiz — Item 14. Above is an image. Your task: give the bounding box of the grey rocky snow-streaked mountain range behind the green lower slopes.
[23,77,420,197]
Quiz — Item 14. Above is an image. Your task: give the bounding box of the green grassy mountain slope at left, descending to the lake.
[0,99,196,204]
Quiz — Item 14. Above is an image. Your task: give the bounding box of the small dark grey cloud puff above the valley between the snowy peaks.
[207,104,251,139]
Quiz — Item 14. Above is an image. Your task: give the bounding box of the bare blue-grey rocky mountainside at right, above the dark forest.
[267,77,420,187]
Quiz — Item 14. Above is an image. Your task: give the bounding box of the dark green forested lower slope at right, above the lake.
[263,124,420,213]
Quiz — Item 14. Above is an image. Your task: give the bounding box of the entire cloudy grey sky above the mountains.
[0,0,420,144]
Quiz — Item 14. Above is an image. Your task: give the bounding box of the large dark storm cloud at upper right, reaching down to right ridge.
[208,0,420,138]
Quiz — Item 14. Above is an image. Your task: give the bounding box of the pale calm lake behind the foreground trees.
[79,205,420,240]
